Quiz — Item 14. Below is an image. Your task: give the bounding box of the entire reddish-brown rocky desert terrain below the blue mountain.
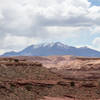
[0,56,100,100]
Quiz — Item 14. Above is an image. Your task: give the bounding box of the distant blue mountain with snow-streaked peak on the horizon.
[2,42,100,57]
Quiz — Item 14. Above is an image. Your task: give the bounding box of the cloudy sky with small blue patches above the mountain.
[0,0,100,54]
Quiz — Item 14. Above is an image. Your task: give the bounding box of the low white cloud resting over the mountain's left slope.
[1,34,40,52]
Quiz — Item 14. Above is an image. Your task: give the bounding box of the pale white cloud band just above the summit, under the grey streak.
[47,26,80,41]
